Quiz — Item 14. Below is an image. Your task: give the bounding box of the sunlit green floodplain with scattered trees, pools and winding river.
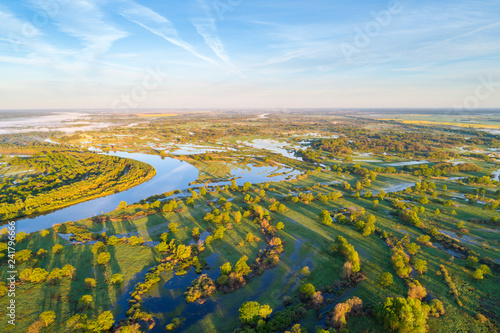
[0,110,500,333]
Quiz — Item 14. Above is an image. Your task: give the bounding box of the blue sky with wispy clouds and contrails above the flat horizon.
[0,0,500,111]
